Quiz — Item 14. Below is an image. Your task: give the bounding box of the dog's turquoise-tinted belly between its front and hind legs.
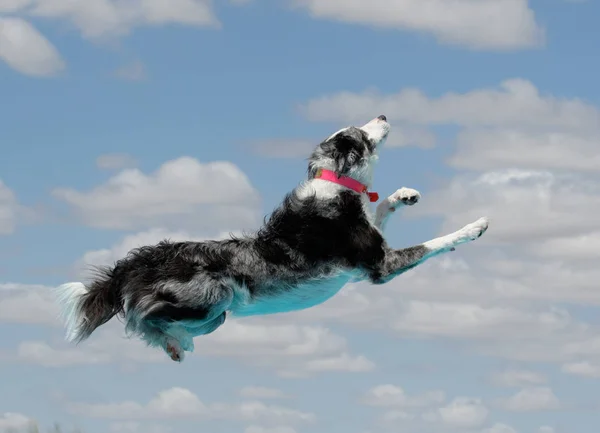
[229,272,355,316]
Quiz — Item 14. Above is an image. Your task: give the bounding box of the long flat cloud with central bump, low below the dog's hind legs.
[67,388,316,424]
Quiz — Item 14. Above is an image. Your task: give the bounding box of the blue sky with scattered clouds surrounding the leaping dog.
[0,0,600,433]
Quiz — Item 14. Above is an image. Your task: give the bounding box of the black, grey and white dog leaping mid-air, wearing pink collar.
[57,115,488,362]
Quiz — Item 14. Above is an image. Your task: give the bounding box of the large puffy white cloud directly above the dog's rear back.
[53,157,259,230]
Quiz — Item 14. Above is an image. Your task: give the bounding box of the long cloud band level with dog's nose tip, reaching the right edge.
[301,78,600,131]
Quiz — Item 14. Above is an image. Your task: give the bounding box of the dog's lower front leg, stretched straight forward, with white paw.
[369,218,489,284]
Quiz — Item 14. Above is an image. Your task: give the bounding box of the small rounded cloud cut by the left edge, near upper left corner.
[0,17,65,77]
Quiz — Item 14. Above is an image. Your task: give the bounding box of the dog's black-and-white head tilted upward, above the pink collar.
[308,115,390,186]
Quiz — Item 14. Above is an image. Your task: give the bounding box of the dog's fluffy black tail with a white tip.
[55,272,123,343]
